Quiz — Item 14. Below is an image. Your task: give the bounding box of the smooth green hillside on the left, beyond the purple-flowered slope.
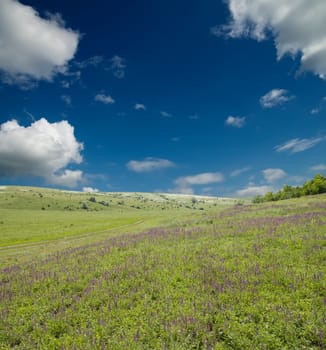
[0,186,238,254]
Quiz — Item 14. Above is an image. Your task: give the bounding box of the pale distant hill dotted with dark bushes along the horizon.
[0,186,239,211]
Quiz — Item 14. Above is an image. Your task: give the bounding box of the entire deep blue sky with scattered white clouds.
[0,0,326,197]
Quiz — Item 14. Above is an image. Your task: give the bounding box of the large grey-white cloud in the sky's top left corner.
[0,0,80,88]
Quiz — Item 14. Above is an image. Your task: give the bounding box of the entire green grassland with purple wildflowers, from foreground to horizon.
[0,187,326,349]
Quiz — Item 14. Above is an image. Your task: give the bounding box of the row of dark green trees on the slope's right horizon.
[253,174,326,203]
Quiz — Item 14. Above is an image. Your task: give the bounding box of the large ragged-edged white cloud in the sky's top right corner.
[220,0,326,79]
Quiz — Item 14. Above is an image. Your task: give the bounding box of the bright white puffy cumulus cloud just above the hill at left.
[0,118,83,187]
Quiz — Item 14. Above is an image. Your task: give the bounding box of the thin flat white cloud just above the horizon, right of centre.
[173,172,224,194]
